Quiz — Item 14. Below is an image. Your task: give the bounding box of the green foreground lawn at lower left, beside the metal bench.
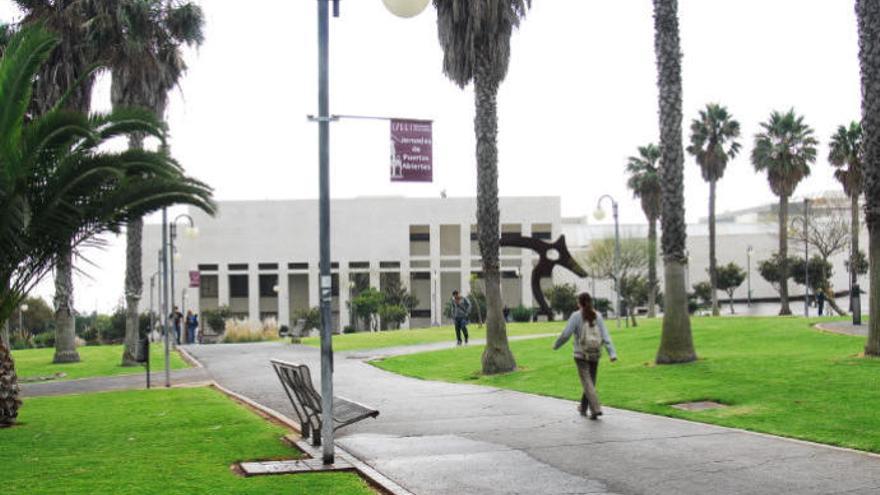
[0,388,375,495]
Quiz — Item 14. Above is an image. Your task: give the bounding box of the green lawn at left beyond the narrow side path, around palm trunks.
[12,343,189,380]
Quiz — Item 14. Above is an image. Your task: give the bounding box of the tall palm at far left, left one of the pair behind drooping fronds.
[15,0,108,363]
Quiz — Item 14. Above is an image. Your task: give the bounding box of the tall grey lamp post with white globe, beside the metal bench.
[314,0,428,464]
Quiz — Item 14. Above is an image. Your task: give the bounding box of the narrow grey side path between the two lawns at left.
[21,368,211,397]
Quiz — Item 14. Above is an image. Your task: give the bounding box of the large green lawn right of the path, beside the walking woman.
[376,317,880,452]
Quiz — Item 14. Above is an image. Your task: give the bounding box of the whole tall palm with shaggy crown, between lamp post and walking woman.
[434,0,531,374]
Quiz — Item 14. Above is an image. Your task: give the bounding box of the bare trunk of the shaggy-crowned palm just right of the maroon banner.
[474,54,516,375]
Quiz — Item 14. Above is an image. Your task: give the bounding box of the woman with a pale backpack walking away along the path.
[553,292,617,419]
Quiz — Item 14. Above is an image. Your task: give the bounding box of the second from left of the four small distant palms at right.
[687,103,740,316]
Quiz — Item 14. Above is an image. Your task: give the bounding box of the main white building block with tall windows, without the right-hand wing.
[141,197,561,329]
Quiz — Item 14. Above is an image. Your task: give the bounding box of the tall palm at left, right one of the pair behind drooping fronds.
[105,0,204,366]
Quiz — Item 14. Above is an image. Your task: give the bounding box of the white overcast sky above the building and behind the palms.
[0,0,860,311]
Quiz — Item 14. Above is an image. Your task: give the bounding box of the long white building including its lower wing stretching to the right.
[141,197,867,329]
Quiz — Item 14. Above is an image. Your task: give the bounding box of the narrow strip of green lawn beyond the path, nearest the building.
[303,322,562,351]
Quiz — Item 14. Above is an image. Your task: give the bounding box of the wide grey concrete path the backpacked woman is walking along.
[187,343,880,495]
